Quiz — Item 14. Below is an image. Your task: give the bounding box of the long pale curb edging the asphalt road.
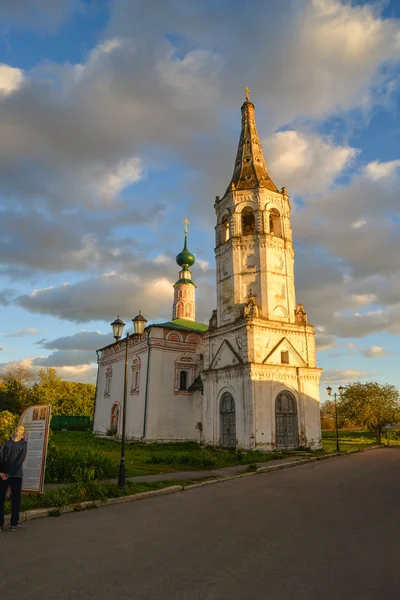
[4,444,386,525]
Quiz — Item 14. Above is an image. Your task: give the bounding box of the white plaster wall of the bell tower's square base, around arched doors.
[203,319,321,449]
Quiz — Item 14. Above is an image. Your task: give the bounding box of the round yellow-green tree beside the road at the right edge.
[338,381,400,444]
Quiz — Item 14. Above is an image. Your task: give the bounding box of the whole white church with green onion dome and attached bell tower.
[93,89,321,450]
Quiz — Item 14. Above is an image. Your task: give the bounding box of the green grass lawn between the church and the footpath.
[51,431,291,477]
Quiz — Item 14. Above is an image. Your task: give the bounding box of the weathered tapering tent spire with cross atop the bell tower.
[225,91,279,195]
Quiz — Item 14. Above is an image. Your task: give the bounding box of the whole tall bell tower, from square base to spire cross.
[203,88,321,449]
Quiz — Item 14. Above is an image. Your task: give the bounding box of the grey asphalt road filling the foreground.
[0,449,400,600]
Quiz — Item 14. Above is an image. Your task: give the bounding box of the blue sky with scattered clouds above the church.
[0,0,400,399]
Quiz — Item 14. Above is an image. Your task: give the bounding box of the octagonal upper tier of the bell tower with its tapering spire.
[215,90,296,326]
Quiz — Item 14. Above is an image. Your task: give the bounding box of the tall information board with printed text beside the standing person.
[19,404,51,494]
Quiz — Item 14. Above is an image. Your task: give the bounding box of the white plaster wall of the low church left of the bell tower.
[93,327,204,441]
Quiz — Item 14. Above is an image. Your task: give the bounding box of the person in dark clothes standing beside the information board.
[0,426,28,531]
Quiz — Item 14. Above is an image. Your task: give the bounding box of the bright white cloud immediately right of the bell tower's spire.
[263,130,358,195]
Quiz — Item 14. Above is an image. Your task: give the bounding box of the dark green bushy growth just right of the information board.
[46,444,118,483]
